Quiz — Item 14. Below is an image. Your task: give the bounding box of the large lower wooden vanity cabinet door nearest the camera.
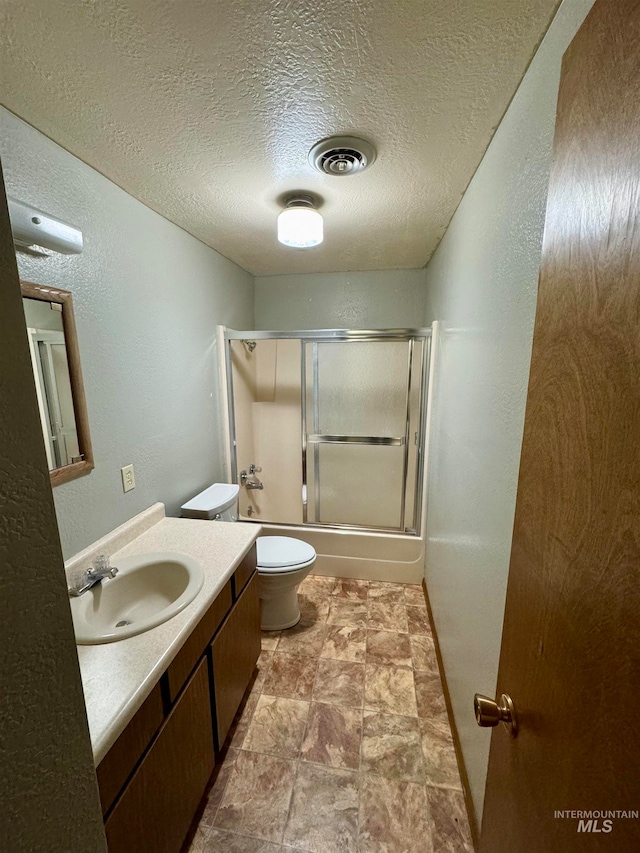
[105,660,214,853]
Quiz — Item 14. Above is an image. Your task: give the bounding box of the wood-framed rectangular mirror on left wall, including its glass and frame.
[20,281,93,486]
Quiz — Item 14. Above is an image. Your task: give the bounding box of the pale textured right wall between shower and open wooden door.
[426,0,592,815]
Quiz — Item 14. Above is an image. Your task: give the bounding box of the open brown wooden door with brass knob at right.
[481,0,640,853]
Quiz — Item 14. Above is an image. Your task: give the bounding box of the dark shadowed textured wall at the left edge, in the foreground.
[0,166,106,853]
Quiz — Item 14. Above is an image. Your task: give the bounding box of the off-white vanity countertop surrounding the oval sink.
[78,511,261,765]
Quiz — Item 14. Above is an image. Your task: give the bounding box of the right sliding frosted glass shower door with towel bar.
[302,338,424,530]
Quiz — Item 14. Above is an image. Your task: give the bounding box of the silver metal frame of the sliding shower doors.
[224,327,432,536]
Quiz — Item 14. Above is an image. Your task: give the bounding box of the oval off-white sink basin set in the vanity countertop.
[71,551,204,646]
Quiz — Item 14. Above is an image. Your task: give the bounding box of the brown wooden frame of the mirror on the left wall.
[20,280,94,487]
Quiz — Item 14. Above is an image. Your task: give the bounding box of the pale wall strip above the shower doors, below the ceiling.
[255,269,426,329]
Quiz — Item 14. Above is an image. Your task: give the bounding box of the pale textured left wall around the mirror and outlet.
[0,110,254,557]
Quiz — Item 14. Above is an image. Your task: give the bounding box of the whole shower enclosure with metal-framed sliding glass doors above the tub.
[224,329,431,536]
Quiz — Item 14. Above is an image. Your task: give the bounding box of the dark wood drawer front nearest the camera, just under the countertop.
[96,684,164,814]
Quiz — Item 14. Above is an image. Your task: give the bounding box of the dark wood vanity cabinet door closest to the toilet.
[211,572,260,749]
